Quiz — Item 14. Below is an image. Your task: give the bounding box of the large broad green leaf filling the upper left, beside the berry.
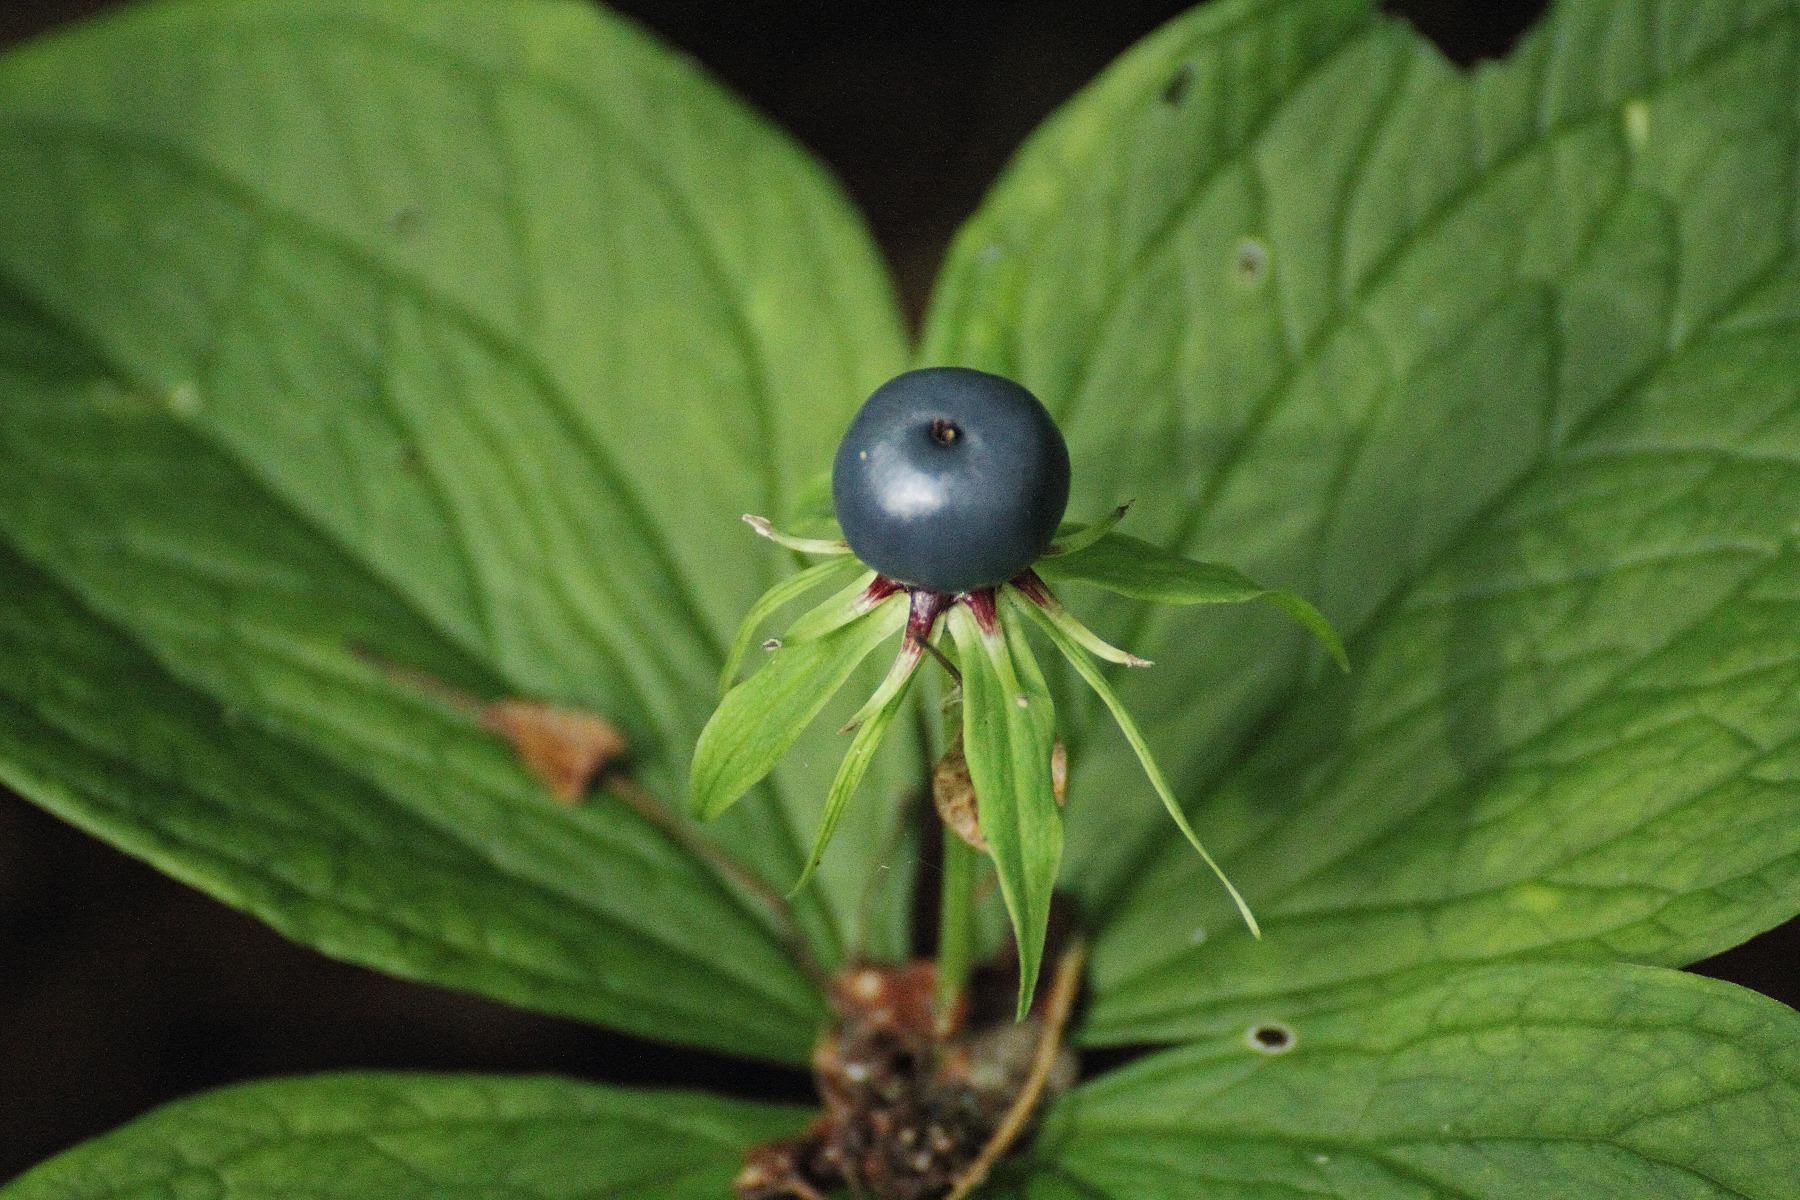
[0,0,911,1056]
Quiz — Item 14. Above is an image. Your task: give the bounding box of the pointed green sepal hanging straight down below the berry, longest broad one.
[947,604,1062,1016]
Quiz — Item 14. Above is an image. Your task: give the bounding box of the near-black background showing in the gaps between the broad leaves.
[0,0,1800,1180]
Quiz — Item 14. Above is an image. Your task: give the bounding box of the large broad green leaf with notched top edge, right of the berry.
[925,0,1800,1042]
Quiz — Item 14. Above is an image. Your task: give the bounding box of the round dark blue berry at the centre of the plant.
[832,367,1069,592]
